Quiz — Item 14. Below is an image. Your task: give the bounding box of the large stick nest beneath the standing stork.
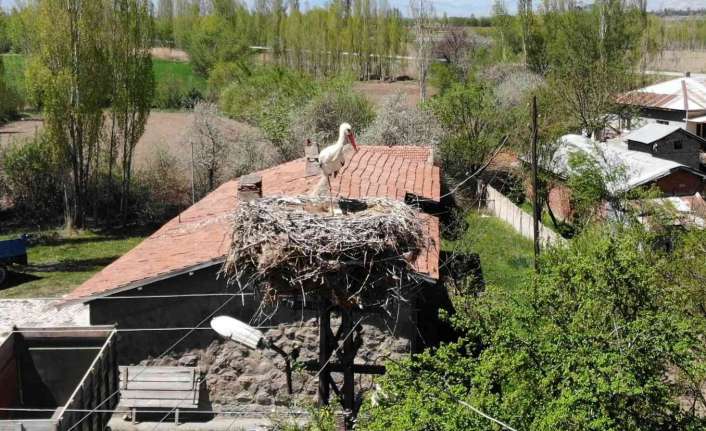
[223,197,426,307]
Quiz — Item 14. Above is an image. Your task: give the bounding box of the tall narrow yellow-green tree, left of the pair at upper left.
[29,0,110,227]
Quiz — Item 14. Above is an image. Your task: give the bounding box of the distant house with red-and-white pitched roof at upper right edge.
[617,74,706,139]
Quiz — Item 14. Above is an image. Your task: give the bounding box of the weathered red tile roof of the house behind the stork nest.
[67,146,441,300]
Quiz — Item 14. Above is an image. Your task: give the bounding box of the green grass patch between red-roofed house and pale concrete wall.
[443,211,534,290]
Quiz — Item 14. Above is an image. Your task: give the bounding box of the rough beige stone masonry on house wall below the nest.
[141,319,402,410]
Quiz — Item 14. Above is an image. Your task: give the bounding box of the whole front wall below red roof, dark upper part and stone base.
[89,265,450,408]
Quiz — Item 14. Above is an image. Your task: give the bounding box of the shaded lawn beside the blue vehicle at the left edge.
[0,230,144,298]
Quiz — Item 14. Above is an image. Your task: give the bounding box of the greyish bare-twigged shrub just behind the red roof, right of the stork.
[359,93,443,147]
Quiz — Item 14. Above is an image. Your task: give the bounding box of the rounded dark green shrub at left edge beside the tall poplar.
[0,134,63,222]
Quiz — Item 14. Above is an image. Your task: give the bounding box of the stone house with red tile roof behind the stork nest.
[62,146,449,418]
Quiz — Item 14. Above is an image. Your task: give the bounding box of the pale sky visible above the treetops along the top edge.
[0,0,706,16]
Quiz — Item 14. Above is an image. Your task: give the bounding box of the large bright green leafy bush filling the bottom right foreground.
[361,225,706,431]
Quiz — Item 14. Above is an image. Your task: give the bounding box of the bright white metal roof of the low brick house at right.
[545,135,706,192]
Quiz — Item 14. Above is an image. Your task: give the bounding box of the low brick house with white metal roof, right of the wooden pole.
[543,133,706,220]
